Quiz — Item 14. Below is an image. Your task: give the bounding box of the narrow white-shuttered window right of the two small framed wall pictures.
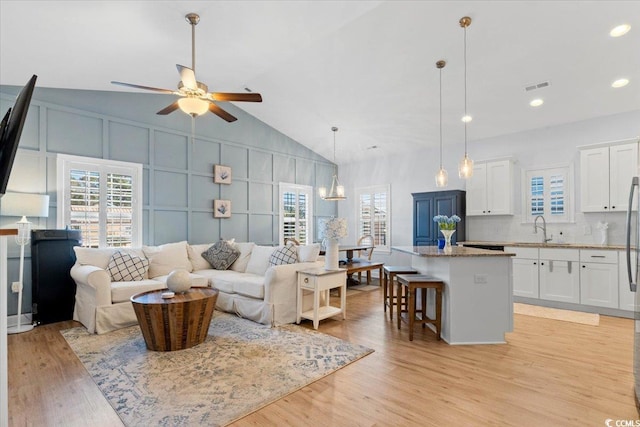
[278,182,313,245]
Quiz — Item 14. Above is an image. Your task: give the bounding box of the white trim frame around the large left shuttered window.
[56,154,143,248]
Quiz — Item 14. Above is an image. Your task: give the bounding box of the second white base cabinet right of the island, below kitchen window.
[539,248,580,304]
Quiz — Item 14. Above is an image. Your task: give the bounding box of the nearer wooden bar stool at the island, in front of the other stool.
[396,274,444,341]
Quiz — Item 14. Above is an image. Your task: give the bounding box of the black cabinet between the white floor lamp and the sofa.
[31,230,82,324]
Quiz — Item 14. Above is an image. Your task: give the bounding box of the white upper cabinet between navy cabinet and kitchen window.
[467,160,513,216]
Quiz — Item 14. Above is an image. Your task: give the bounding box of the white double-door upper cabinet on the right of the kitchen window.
[580,141,638,212]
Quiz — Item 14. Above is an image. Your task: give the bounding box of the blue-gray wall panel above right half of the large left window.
[109,122,149,165]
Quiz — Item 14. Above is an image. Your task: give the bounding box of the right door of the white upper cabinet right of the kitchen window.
[609,142,638,212]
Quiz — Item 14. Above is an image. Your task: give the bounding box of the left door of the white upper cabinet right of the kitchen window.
[580,147,608,212]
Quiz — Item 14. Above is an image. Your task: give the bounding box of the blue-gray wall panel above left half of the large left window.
[47,108,102,157]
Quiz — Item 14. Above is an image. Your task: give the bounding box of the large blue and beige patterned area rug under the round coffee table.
[61,312,373,426]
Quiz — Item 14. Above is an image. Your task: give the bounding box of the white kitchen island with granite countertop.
[392,246,514,344]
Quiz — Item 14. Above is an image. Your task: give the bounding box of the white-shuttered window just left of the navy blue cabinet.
[356,185,391,251]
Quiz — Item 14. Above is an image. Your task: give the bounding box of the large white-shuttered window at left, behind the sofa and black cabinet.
[57,154,142,248]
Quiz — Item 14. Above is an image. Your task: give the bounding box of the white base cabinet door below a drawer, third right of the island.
[580,262,618,308]
